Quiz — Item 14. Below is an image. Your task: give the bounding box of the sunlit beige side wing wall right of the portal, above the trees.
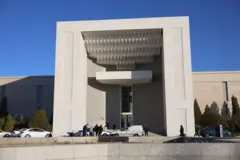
[193,71,240,112]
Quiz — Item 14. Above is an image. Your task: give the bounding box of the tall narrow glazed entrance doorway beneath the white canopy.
[121,86,133,128]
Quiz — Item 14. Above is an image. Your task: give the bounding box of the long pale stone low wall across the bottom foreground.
[0,143,240,160]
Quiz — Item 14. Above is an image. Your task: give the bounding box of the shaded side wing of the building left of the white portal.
[0,76,54,118]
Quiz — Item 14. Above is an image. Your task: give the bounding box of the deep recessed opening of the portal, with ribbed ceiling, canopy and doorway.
[82,28,164,133]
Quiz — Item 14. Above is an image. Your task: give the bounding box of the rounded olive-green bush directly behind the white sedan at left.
[29,109,51,130]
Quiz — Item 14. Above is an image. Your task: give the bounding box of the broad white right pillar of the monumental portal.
[163,25,194,136]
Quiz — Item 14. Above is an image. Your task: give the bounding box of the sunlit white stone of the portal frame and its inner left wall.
[53,17,194,136]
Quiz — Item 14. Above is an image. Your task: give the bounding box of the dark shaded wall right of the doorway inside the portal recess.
[133,57,165,133]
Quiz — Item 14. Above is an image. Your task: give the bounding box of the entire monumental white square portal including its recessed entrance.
[53,17,195,136]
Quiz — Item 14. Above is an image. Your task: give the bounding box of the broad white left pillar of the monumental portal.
[53,27,87,136]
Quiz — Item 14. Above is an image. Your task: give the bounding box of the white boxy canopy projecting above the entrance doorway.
[96,71,152,85]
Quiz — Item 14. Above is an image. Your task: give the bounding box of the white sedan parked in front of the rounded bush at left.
[21,128,52,138]
